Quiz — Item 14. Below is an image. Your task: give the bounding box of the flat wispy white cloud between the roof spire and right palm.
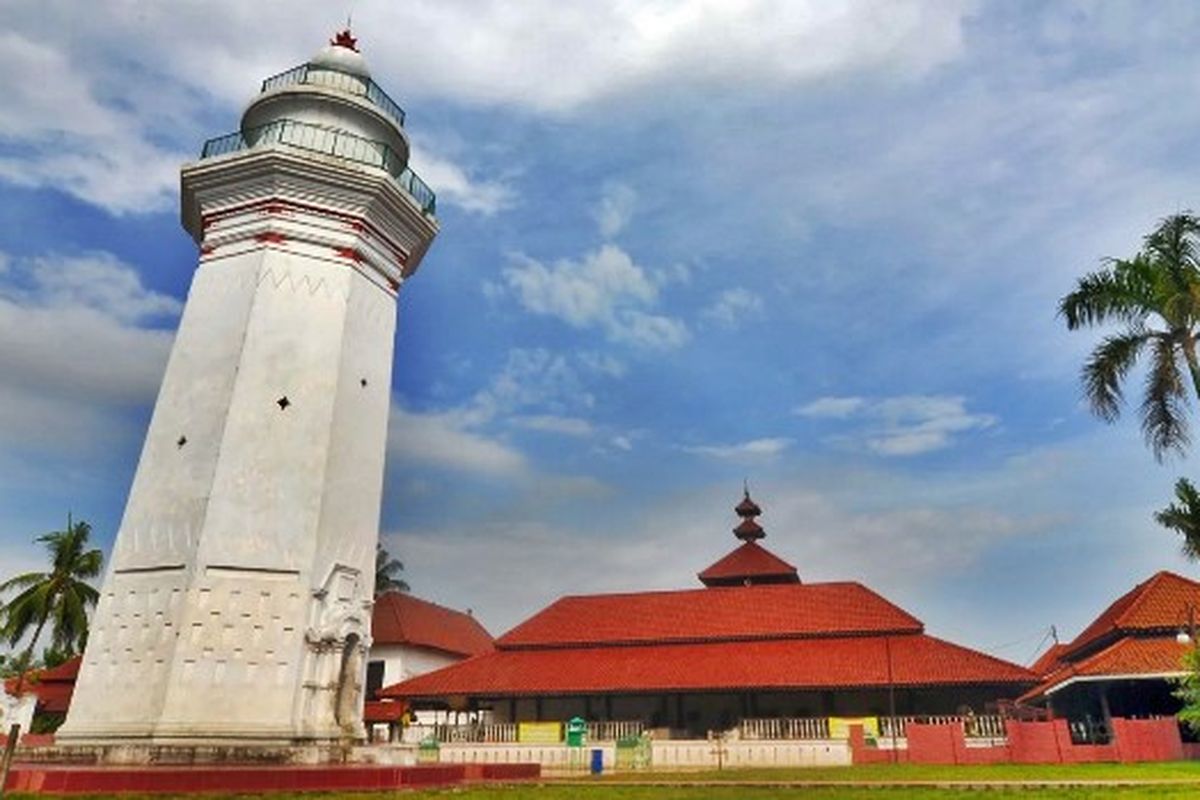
[796,395,997,456]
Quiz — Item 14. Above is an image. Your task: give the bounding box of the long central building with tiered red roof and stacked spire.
[382,493,1036,736]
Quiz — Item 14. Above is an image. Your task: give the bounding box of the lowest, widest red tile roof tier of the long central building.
[382,633,1037,699]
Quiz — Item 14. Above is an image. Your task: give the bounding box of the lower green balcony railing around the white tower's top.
[200,120,437,216]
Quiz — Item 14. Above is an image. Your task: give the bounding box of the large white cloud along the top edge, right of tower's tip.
[369,0,968,112]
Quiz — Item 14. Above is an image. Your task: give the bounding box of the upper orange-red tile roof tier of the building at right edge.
[1064,570,1200,660]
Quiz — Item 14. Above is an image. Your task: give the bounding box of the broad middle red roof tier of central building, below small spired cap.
[496,583,924,649]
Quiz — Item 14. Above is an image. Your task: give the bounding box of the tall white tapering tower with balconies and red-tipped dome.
[59,26,438,746]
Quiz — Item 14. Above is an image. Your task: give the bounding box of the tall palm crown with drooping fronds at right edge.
[1058,211,1200,462]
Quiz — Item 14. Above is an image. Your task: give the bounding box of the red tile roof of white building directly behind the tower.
[371,591,492,656]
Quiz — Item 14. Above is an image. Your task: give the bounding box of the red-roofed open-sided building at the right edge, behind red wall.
[1020,571,1200,724]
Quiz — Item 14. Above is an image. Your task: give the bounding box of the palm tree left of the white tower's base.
[0,515,104,694]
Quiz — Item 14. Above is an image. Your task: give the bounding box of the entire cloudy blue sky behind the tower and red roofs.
[0,0,1200,661]
